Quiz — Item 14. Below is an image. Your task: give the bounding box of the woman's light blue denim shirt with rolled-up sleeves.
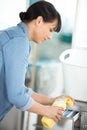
[0,22,34,120]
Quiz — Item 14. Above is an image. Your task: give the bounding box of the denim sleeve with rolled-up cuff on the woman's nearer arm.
[3,37,34,111]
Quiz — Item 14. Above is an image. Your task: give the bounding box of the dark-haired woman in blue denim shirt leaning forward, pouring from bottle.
[0,1,75,122]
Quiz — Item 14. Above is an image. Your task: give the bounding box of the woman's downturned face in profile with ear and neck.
[31,16,58,44]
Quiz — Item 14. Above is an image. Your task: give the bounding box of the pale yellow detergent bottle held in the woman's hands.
[41,98,73,130]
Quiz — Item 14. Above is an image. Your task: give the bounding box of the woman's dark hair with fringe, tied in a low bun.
[19,0,61,32]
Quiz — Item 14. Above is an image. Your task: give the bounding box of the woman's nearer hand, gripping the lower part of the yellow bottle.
[45,106,64,122]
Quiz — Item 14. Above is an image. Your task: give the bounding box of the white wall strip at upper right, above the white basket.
[72,0,87,48]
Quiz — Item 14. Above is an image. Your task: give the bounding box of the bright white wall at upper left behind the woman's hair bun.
[0,0,27,29]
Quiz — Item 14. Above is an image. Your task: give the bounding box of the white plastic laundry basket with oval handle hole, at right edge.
[60,49,87,102]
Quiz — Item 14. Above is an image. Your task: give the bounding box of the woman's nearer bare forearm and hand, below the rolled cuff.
[27,99,64,122]
